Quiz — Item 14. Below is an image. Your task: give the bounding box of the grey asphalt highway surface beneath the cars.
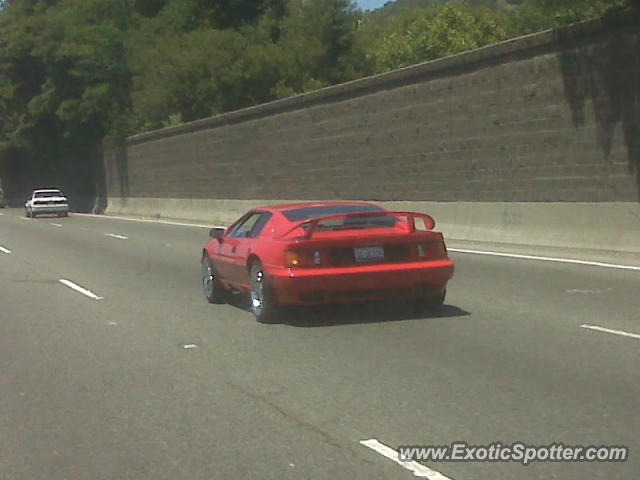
[0,209,640,480]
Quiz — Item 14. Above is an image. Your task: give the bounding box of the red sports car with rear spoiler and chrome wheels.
[201,202,453,323]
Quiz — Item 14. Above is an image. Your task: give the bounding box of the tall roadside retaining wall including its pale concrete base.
[105,5,640,251]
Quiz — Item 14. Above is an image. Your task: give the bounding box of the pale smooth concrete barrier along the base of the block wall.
[109,198,640,254]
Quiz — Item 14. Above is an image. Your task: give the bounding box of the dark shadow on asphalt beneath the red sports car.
[225,295,470,328]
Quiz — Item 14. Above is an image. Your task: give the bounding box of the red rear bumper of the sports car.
[267,259,454,305]
